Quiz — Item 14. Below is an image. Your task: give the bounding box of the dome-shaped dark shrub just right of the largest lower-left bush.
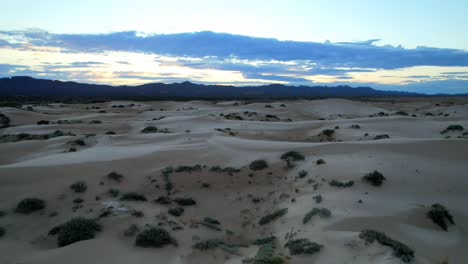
[135,227,177,248]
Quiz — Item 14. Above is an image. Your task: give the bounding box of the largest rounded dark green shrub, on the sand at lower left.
[56,217,102,247]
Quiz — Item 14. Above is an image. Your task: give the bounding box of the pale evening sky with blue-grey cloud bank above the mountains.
[0,0,468,93]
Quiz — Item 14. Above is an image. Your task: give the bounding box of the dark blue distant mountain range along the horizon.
[0,76,432,100]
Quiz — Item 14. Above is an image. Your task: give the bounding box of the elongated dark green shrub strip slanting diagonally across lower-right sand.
[359,229,414,262]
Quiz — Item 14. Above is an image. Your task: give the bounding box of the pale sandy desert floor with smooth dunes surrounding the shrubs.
[0,98,468,264]
